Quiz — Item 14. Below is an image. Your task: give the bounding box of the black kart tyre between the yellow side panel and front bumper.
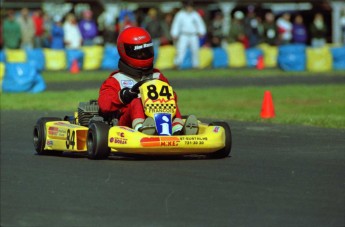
[87,122,110,159]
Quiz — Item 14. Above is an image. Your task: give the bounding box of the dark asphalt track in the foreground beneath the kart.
[0,75,345,227]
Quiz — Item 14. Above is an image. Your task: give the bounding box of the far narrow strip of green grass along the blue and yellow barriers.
[42,68,345,82]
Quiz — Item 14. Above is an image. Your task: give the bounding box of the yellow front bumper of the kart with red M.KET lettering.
[108,123,225,155]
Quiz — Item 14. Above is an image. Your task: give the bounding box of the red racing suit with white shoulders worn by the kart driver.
[98,69,183,128]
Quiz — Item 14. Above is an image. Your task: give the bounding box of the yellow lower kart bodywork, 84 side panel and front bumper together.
[39,121,225,155]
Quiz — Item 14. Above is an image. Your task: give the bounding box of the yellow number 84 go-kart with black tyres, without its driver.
[33,79,232,159]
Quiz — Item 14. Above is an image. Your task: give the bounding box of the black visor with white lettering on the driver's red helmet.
[124,42,153,60]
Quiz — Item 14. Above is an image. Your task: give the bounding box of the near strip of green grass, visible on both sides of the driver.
[1,85,345,128]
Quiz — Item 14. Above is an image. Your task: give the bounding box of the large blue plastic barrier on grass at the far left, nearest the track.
[2,63,46,93]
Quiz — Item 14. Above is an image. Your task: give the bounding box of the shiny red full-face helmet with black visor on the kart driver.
[117,27,154,68]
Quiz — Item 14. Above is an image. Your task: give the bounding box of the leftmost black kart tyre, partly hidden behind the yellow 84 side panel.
[33,117,62,155]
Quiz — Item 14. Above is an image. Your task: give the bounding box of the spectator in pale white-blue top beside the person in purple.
[63,13,83,48]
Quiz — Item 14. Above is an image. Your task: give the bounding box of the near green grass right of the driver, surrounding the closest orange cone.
[176,85,345,128]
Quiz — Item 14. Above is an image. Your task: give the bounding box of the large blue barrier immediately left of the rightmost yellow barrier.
[278,44,306,71]
